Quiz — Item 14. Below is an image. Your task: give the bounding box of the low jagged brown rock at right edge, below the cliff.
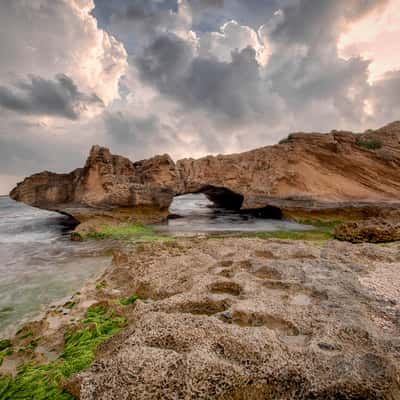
[334,219,400,243]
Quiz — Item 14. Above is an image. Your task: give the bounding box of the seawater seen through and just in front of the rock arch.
[153,194,312,236]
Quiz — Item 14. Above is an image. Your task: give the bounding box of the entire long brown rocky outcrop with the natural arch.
[10,122,400,222]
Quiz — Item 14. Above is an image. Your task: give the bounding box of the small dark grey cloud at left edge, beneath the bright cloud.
[0,74,102,119]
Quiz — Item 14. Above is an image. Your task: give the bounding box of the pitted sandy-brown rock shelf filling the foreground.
[66,238,400,400]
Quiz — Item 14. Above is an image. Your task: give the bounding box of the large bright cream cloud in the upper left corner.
[0,0,127,105]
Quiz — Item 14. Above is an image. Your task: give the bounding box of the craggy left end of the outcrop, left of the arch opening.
[10,146,179,223]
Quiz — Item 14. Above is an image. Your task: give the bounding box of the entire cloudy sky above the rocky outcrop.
[0,0,400,194]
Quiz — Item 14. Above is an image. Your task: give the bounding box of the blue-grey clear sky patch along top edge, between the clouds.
[93,0,282,39]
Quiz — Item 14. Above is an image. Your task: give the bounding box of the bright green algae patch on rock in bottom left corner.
[0,306,126,400]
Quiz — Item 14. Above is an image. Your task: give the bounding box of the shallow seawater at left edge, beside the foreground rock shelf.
[0,196,111,333]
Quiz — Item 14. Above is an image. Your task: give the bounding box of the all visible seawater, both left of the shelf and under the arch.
[0,194,310,334]
